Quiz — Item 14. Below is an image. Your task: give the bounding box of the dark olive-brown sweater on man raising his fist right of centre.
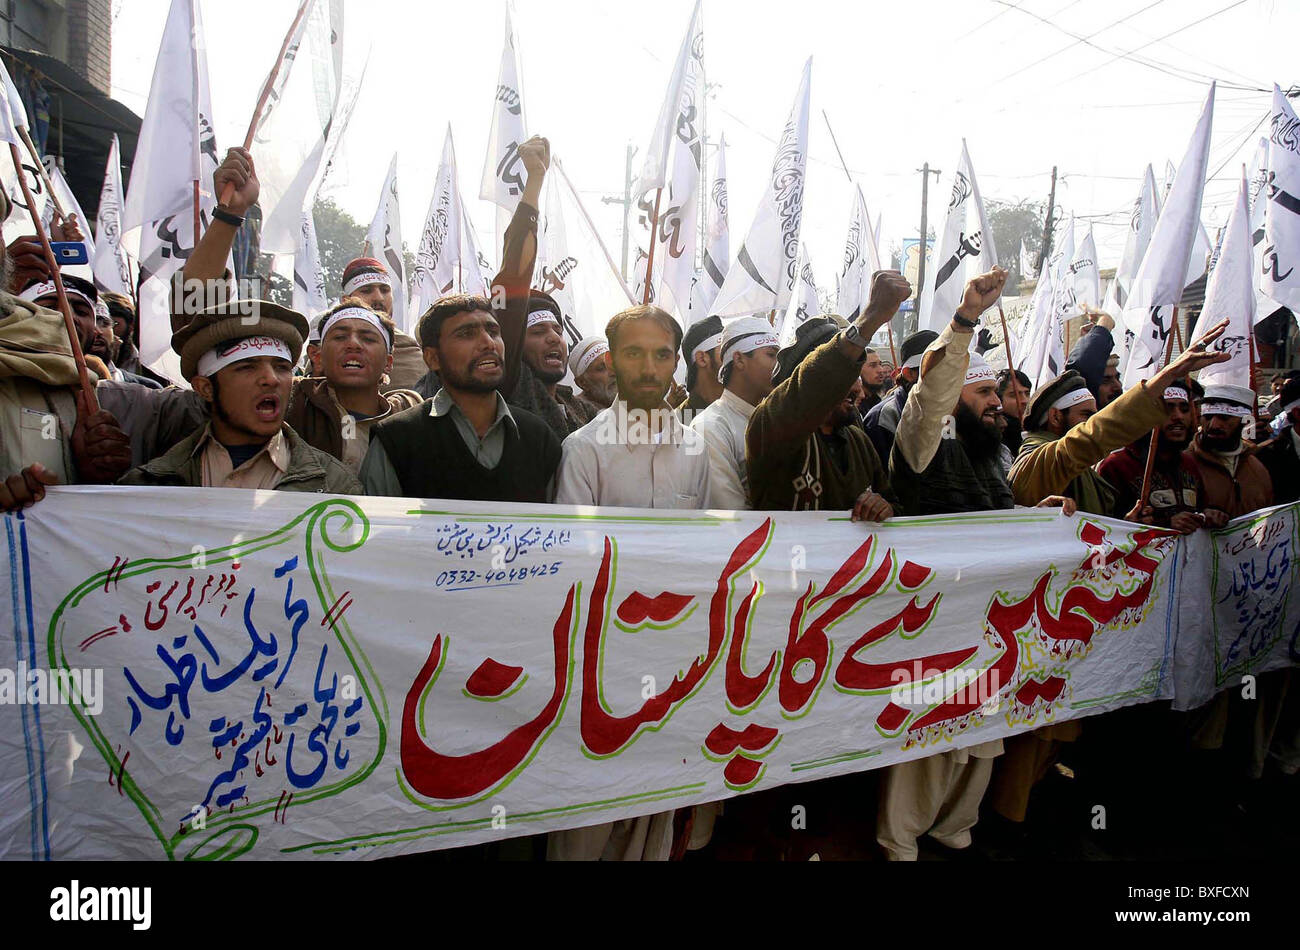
[745,339,902,513]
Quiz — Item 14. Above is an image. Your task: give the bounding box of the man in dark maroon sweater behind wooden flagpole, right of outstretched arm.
[1097,379,1205,534]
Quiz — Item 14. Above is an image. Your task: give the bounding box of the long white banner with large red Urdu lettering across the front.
[0,486,1300,860]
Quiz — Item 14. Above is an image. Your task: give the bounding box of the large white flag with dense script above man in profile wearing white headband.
[711,57,813,318]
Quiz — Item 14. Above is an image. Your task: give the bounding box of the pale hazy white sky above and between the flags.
[113,0,1300,289]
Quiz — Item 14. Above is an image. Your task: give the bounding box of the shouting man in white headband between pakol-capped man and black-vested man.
[285,296,424,474]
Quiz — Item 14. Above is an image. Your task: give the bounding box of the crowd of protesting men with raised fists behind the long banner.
[0,138,1300,860]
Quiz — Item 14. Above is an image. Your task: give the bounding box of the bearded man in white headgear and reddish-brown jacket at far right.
[1192,385,1273,519]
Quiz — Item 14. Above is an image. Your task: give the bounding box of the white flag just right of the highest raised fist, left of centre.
[533,155,640,348]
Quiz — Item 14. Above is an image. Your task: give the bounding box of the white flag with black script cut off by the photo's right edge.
[1260,86,1300,312]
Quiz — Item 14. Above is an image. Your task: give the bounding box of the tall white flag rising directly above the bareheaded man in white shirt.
[631,3,705,315]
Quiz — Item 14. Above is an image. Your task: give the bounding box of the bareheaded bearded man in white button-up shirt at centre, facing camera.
[546,305,712,860]
